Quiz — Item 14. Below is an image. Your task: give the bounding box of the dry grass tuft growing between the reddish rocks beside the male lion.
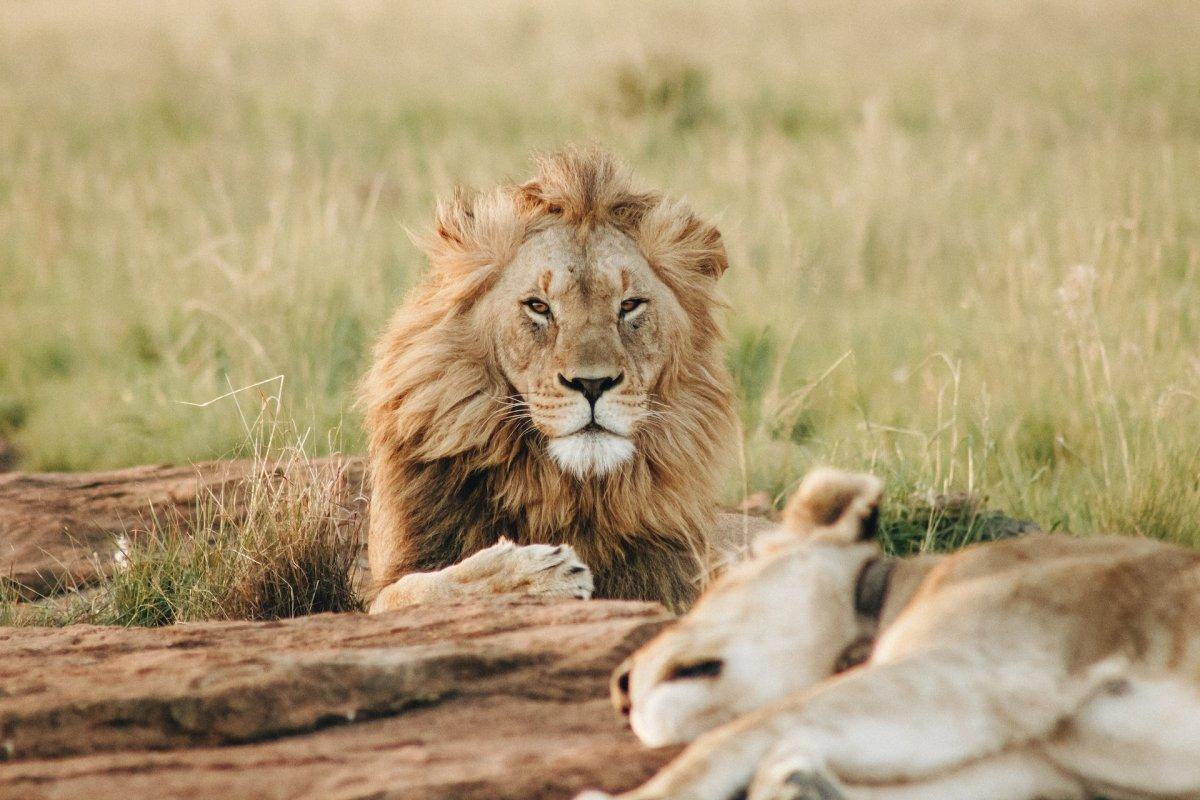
[0,410,364,627]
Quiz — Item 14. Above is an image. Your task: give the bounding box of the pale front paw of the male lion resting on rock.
[451,539,594,600]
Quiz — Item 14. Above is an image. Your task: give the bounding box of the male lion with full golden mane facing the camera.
[361,149,768,612]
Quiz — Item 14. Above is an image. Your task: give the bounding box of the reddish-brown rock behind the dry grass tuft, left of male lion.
[0,458,364,597]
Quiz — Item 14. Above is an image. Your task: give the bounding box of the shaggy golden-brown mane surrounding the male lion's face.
[361,149,734,607]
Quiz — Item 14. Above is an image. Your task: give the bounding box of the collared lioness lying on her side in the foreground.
[578,470,1200,800]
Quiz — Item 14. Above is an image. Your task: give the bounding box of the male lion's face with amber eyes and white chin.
[476,223,686,477]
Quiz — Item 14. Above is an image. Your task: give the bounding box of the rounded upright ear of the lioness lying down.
[784,469,883,545]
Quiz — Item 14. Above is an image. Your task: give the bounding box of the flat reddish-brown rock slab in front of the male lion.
[0,600,676,800]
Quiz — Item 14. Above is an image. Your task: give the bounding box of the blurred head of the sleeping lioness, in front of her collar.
[612,470,882,747]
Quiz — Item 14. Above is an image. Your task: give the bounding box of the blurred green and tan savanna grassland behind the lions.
[0,0,1200,545]
